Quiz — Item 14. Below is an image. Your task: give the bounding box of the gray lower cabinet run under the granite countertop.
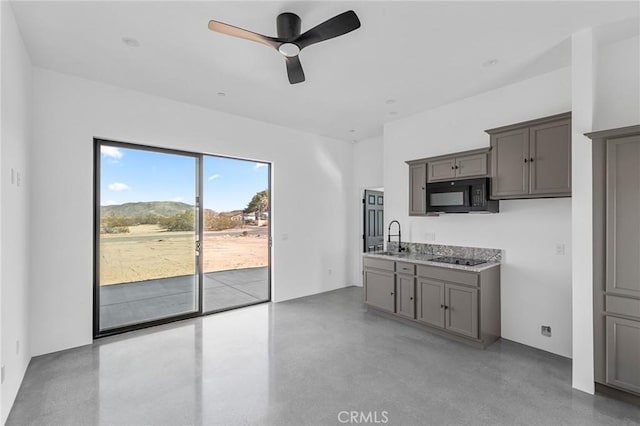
[364,257,501,346]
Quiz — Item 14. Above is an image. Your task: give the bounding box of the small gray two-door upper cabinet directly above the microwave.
[427,149,488,182]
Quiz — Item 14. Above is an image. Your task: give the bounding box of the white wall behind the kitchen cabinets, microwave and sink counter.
[384,68,571,357]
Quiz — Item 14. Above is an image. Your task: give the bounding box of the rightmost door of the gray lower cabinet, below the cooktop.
[444,284,478,338]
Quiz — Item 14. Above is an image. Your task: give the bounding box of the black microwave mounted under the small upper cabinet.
[427,178,499,213]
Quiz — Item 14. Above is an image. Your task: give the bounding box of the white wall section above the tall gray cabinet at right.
[593,36,640,130]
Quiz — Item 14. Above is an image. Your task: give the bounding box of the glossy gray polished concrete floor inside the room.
[7,287,640,425]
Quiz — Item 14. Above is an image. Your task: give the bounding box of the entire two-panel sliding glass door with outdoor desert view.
[94,141,270,336]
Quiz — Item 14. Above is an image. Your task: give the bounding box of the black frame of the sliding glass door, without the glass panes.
[93,137,272,339]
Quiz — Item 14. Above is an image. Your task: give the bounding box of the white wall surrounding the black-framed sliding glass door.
[31,68,352,355]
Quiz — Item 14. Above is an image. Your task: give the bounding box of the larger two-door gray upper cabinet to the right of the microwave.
[486,112,571,199]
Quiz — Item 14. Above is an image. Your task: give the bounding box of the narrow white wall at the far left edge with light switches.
[0,2,32,424]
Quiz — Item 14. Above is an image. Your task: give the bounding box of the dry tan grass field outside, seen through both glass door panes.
[100,225,269,285]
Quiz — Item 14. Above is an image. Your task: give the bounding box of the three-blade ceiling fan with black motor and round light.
[209,10,360,84]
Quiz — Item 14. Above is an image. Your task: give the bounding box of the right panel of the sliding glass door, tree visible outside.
[202,156,270,312]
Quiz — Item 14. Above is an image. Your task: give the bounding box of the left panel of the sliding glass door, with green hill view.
[95,141,199,334]
